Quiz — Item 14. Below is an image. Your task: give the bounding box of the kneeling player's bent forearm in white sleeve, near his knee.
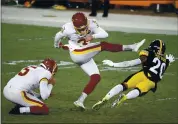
[40,78,54,100]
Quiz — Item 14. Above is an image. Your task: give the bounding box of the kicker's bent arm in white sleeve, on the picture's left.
[54,26,67,48]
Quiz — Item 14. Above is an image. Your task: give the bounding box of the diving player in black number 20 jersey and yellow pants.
[92,39,175,110]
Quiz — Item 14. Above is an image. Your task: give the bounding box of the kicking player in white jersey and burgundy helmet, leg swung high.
[54,12,145,109]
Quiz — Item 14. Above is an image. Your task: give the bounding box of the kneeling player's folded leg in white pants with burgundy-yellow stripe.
[3,86,49,114]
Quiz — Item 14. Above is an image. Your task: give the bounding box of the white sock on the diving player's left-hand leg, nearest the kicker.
[105,84,123,100]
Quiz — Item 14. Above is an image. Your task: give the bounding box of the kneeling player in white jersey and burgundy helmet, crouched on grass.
[3,58,58,115]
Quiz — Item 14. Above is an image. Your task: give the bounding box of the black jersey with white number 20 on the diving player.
[139,49,169,83]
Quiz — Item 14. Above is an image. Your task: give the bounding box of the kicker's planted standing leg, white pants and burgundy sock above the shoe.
[79,59,101,102]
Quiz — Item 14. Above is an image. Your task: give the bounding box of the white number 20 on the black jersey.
[149,58,166,79]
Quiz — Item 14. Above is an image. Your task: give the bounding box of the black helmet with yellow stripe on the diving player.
[148,39,166,55]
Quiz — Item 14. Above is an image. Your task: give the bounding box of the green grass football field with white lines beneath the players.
[1,23,178,124]
